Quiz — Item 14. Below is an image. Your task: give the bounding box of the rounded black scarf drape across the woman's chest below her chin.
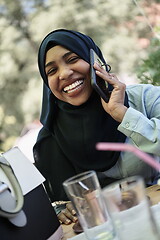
[54,91,125,171]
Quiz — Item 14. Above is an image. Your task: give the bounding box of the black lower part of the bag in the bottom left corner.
[0,185,60,240]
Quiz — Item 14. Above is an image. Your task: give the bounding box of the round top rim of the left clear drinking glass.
[63,170,96,186]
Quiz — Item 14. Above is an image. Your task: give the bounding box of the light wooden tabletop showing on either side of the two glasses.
[62,185,160,240]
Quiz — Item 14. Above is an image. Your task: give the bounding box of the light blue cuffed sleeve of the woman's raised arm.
[118,84,160,156]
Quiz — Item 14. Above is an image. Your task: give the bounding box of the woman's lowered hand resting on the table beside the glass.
[57,202,78,225]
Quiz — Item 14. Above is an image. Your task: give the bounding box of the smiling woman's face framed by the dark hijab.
[45,45,92,106]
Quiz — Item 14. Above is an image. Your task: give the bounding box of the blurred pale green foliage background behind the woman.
[0,0,160,159]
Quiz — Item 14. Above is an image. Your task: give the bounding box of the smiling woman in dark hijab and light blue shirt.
[34,29,160,224]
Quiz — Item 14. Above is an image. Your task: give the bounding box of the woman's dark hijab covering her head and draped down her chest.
[34,30,128,201]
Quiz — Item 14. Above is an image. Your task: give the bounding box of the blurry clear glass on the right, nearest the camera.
[102,176,160,240]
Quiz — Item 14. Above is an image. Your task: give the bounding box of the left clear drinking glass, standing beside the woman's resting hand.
[63,171,117,240]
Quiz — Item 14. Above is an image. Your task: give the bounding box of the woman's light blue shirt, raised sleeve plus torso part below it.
[105,84,160,184]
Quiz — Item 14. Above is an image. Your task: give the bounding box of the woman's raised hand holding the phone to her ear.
[94,63,127,122]
